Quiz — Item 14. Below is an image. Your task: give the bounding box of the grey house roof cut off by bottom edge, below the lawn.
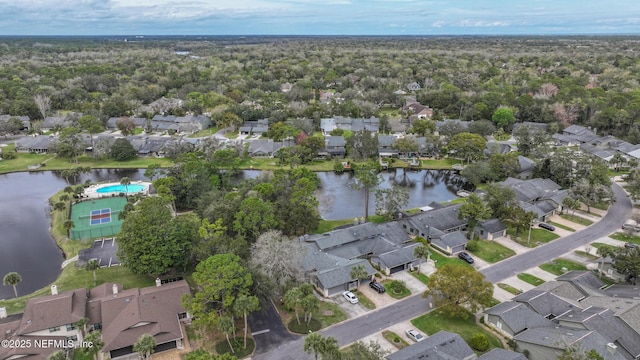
[385,330,477,360]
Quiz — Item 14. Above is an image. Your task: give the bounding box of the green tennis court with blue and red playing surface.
[70,197,127,240]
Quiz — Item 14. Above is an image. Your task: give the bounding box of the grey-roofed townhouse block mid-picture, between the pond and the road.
[302,221,418,297]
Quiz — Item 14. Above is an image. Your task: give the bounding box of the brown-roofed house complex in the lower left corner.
[0,280,189,360]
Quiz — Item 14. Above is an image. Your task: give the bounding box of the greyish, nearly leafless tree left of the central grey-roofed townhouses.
[249,230,305,289]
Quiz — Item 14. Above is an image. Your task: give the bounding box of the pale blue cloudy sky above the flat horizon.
[0,0,640,35]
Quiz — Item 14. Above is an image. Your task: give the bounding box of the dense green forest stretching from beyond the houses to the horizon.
[0,36,640,143]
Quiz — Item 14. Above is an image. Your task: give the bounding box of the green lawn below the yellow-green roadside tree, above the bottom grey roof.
[411,310,503,350]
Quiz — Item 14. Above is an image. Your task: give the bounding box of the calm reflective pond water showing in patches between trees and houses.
[0,169,469,299]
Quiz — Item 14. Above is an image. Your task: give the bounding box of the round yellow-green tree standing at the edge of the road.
[423,264,493,319]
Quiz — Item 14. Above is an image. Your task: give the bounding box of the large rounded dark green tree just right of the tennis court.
[118,197,194,276]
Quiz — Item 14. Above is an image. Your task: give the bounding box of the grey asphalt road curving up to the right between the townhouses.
[253,184,632,360]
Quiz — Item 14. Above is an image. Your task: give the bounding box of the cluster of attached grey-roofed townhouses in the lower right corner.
[484,271,640,360]
